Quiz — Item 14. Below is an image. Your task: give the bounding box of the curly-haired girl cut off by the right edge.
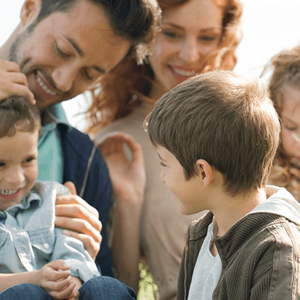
[264,46,300,201]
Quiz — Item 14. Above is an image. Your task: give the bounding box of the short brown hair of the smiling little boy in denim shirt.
[0,96,41,138]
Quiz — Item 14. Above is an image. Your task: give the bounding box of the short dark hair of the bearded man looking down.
[30,0,160,60]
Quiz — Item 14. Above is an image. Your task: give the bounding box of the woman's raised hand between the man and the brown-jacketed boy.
[98,132,146,207]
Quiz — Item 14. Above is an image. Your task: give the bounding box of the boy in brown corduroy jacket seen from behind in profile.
[145,71,300,300]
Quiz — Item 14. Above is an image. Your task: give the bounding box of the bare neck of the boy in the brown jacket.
[211,188,267,236]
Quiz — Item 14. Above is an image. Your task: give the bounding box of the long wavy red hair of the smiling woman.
[86,0,243,133]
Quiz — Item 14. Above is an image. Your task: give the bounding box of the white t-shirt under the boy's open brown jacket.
[188,223,222,300]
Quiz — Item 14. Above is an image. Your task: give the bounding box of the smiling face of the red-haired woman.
[150,0,223,97]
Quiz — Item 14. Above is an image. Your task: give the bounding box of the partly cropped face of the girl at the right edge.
[281,86,300,159]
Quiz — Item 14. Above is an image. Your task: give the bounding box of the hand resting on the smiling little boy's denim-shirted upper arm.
[55,182,102,260]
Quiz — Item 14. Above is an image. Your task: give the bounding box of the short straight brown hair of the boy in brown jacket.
[145,71,280,196]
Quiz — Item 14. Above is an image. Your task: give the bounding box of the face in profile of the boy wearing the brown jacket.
[157,146,207,215]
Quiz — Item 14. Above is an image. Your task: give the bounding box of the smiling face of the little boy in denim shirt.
[0,128,39,211]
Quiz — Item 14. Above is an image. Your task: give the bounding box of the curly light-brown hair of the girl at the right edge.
[262,45,300,201]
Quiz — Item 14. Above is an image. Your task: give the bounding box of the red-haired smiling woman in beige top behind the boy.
[87,0,242,299]
